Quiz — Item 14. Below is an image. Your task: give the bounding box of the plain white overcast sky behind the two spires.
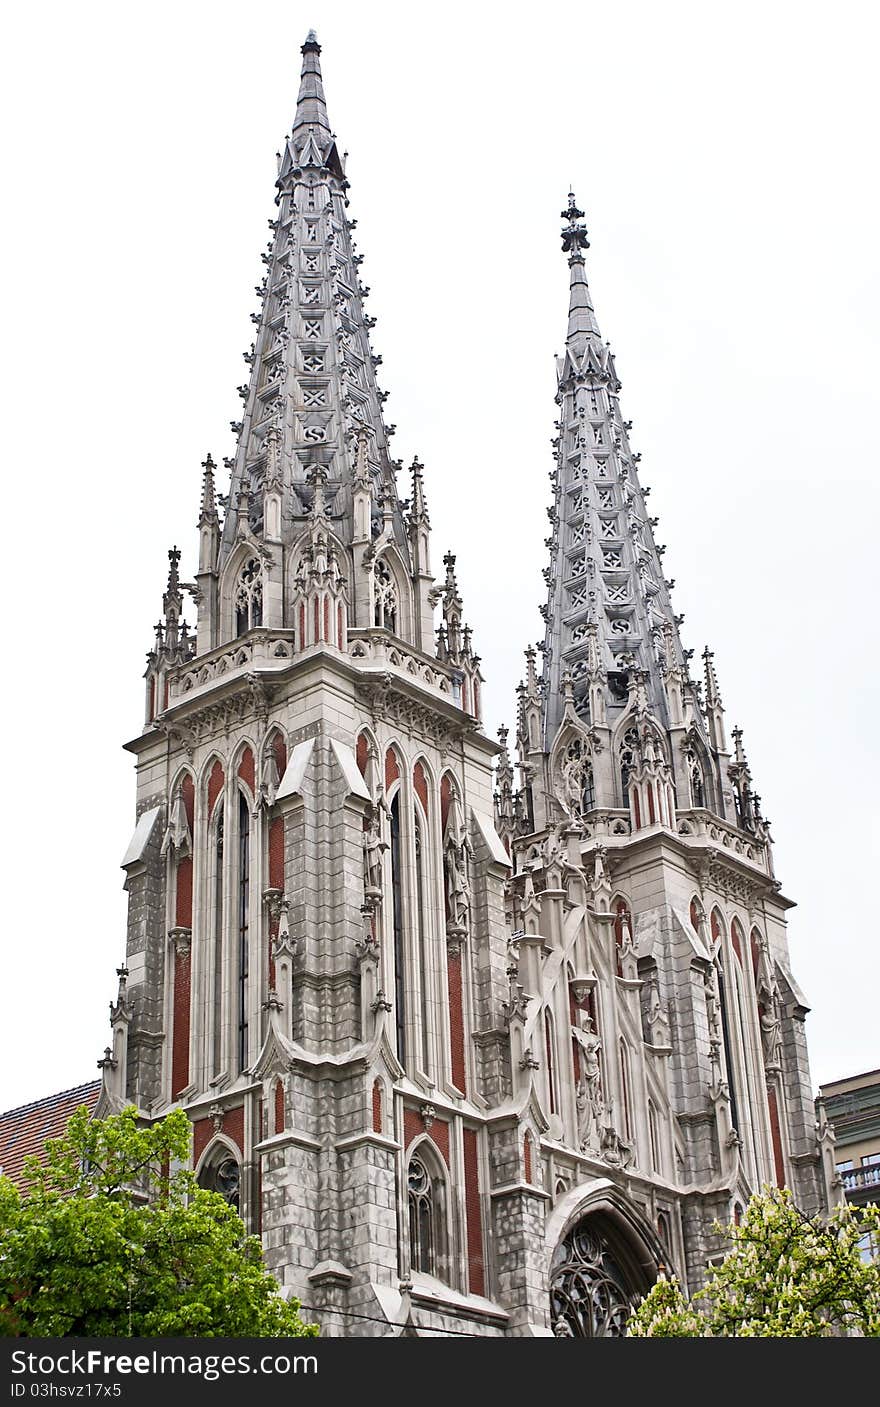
[0,0,880,1109]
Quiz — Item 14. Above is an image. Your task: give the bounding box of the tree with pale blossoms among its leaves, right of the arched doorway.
[627,1188,880,1338]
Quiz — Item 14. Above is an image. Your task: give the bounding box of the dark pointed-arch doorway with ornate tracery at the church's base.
[551,1213,652,1338]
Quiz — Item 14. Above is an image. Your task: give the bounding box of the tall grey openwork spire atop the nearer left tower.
[220,31,410,567]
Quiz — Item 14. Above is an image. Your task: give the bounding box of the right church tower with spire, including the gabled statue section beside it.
[497,194,835,1335]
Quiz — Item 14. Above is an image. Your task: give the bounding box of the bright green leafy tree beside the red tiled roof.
[0,1107,318,1338]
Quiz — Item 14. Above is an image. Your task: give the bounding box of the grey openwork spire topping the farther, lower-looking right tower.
[541,194,703,749]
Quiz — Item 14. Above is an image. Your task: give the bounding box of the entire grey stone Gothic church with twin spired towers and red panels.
[92,34,834,1337]
